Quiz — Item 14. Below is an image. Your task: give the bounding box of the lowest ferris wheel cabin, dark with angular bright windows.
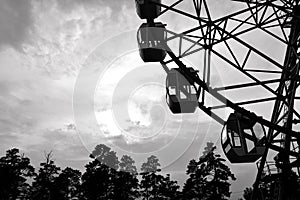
[221,112,266,163]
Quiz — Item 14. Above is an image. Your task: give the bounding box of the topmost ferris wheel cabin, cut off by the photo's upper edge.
[135,0,161,19]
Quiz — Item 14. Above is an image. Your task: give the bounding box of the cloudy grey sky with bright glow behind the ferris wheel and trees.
[0,0,292,199]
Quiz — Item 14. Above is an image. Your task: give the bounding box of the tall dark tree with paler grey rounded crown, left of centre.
[82,144,119,200]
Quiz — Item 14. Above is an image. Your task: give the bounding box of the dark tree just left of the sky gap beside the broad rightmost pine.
[140,156,179,200]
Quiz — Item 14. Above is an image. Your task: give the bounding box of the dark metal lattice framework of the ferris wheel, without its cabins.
[143,0,300,199]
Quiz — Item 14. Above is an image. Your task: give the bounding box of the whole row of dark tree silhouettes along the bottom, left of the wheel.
[0,143,236,200]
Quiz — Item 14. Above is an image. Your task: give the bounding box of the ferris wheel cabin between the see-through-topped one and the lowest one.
[166,69,198,114]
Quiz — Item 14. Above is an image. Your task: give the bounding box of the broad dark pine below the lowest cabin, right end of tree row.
[182,146,235,200]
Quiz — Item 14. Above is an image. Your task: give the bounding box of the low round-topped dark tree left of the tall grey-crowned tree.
[54,167,81,200]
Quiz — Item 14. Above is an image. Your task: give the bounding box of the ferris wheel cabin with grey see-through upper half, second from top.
[137,22,167,62]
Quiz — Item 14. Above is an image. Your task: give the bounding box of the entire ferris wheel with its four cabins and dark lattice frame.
[135,0,300,200]
